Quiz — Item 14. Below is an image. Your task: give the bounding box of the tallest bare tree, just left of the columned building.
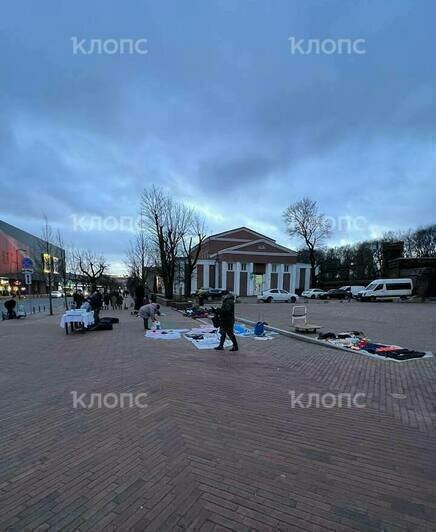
[141,186,193,299]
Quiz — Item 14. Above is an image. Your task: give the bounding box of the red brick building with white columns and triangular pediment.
[192,227,310,296]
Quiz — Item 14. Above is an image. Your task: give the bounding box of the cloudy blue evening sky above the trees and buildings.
[0,0,436,273]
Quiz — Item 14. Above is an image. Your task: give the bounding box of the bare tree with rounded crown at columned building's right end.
[283,197,331,286]
